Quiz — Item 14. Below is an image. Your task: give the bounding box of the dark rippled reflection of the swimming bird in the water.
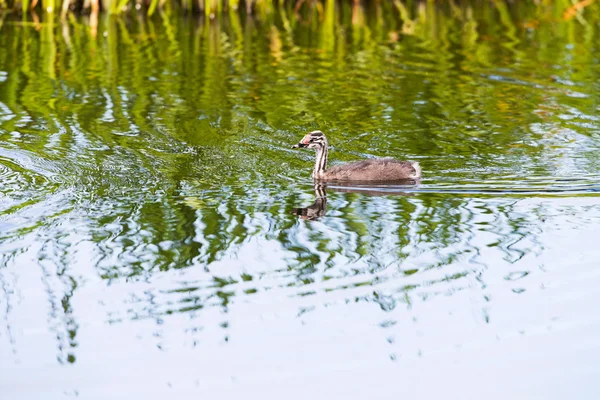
[292,180,419,221]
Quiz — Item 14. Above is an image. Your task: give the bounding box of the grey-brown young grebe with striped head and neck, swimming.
[292,131,421,182]
